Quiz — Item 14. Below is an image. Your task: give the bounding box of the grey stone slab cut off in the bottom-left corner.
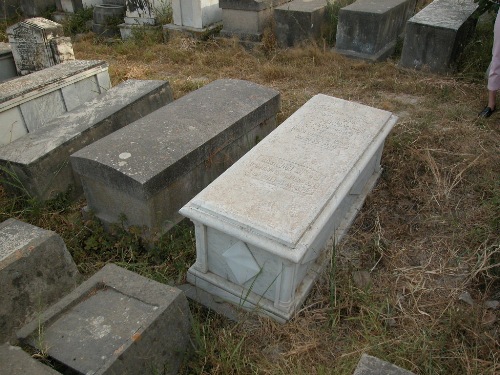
[0,343,60,375]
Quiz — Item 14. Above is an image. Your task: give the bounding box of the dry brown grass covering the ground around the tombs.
[4,14,500,375]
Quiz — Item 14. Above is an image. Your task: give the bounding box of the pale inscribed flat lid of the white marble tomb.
[181,95,397,253]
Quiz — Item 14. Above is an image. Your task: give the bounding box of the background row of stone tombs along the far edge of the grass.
[44,0,477,73]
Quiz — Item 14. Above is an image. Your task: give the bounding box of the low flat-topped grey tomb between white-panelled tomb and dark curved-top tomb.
[0,80,173,200]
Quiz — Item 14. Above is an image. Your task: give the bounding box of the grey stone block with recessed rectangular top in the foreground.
[17,264,191,375]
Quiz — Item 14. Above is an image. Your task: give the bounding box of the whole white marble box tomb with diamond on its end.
[180,95,397,321]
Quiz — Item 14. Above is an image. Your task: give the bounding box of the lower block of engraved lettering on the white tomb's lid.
[249,155,325,195]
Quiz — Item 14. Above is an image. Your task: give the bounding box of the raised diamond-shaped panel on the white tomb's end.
[222,241,260,285]
